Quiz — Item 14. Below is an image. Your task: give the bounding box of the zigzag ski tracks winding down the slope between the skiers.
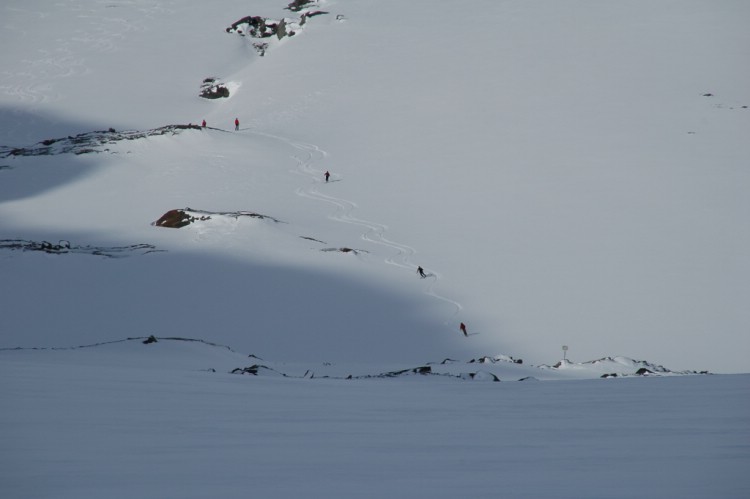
[252,131,463,327]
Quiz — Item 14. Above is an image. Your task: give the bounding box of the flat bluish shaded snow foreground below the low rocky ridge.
[0,338,750,499]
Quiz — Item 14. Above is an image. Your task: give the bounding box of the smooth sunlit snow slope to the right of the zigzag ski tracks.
[229,1,750,370]
